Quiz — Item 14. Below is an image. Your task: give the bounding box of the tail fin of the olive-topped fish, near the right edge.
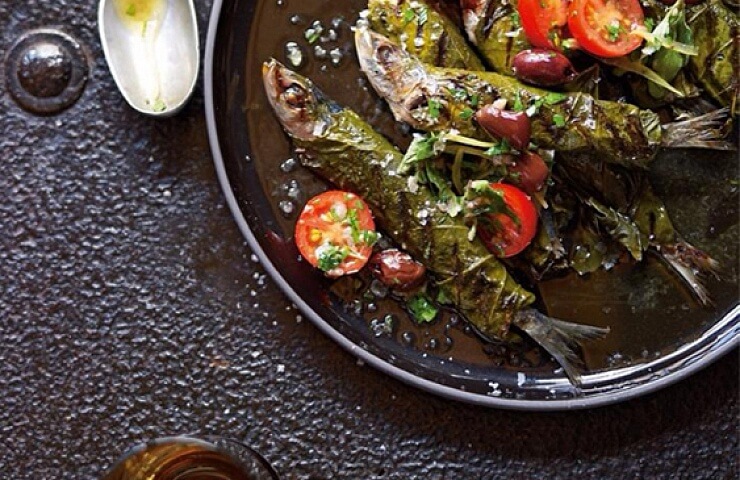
[661,108,736,150]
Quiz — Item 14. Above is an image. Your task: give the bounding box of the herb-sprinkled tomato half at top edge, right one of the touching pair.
[568,0,645,58]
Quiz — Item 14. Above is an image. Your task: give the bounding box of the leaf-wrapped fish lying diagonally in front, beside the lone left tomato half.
[263,60,608,383]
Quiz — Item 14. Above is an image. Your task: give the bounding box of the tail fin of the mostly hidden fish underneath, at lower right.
[658,241,720,306]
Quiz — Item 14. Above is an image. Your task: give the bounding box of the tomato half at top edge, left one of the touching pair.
[517,0,568,48]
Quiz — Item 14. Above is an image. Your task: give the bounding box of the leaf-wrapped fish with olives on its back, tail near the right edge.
[355,29,734,168]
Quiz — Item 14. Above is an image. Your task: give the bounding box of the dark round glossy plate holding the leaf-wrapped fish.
[205,0,740,410]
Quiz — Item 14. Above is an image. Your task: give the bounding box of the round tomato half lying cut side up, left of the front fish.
[295,190,377,277]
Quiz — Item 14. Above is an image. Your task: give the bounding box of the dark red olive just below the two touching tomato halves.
[511,48,576,87]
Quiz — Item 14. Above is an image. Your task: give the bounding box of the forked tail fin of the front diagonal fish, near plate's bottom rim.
[512,309,609,386]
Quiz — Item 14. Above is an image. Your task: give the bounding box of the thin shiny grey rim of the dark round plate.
[204,0,740,412]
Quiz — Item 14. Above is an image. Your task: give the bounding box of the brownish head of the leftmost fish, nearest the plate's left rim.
[262,58,319,141]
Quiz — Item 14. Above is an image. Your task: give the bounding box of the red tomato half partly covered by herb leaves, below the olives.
[478,183,537,258]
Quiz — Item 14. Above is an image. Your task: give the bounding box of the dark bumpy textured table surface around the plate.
[0,0,738,479]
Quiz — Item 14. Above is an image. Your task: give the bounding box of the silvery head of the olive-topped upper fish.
[355,28,426,107]
